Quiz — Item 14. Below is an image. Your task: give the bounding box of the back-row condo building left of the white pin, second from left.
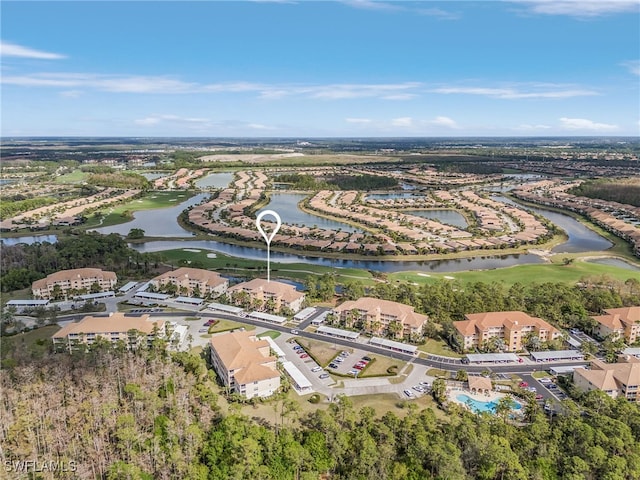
[150,267,229,297]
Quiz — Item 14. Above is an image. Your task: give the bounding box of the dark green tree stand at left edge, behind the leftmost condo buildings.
[0,232,157,292]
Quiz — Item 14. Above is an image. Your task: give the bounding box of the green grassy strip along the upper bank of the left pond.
[82,190,195,228]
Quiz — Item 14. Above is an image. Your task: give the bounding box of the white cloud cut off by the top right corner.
[511,0,640,17]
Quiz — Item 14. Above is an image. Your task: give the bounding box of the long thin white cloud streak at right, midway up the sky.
[431,84,598,100]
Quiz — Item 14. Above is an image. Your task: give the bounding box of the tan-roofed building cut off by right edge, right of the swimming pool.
[573,355,640,403]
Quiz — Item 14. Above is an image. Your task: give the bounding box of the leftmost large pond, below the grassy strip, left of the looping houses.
[90,193,209,237]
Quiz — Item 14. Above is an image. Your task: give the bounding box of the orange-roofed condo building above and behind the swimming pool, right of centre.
[453,311,562,352]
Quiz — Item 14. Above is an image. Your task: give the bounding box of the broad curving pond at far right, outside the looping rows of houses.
[491,195,613,253]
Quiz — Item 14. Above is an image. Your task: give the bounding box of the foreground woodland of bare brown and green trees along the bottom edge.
[0,345,640,480]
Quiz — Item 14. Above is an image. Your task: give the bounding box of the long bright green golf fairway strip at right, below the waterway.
[389,258,638,286]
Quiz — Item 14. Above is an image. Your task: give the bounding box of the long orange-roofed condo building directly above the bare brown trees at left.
[51,312,170,352]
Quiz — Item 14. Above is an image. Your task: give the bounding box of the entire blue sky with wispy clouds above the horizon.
[0,0,640,137]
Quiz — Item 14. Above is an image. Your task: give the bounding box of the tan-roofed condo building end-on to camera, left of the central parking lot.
[211,331,280,398]
